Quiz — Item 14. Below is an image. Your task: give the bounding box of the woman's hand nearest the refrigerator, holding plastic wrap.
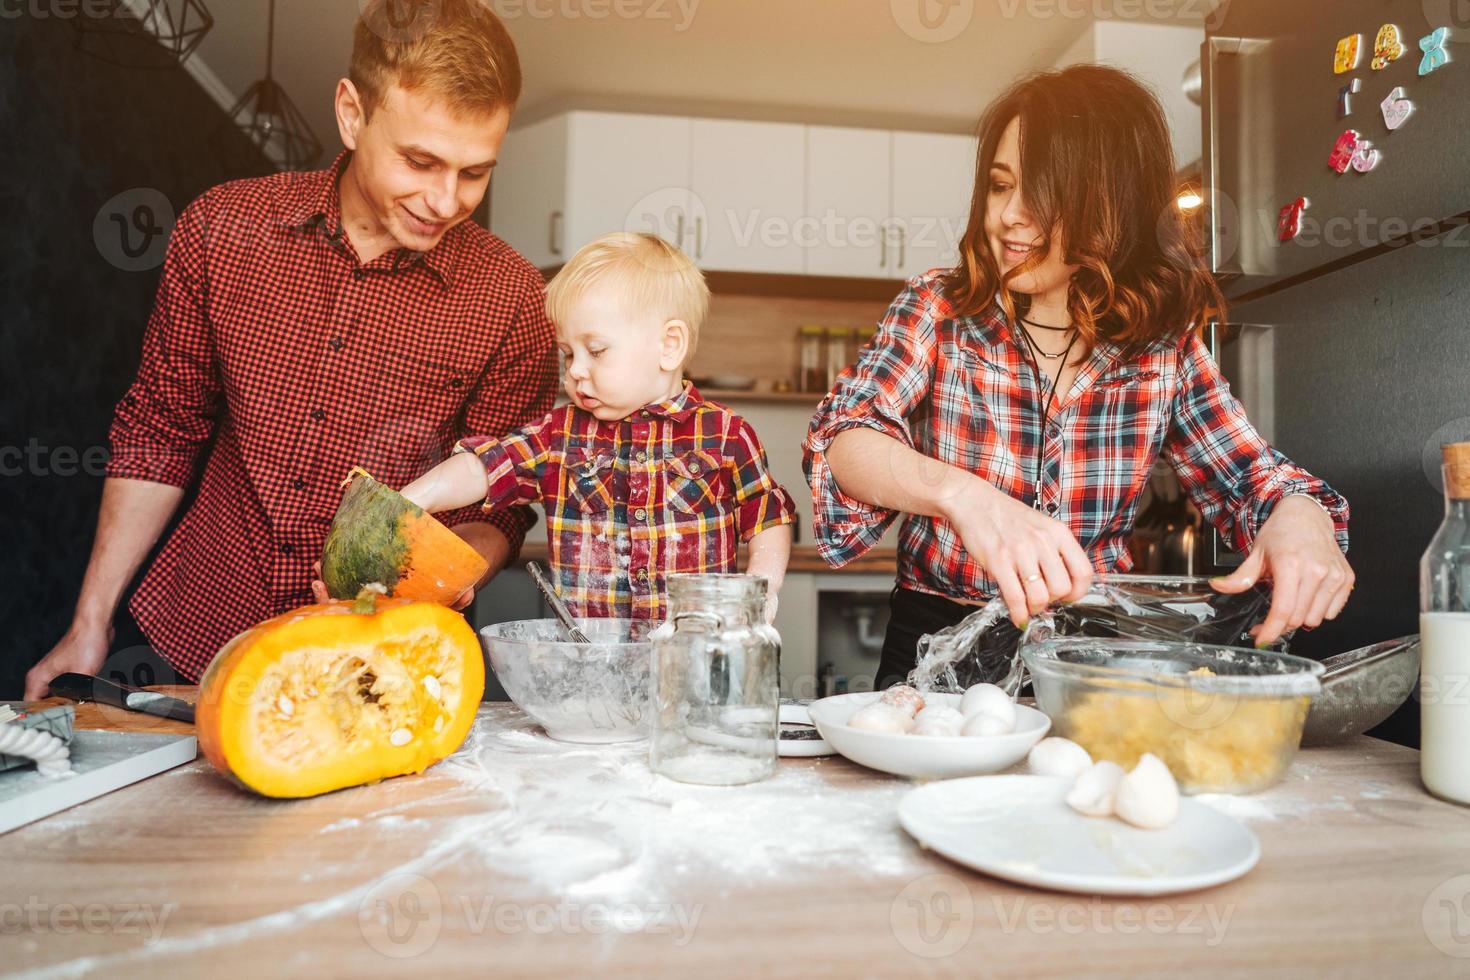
[1211,494,1355,646]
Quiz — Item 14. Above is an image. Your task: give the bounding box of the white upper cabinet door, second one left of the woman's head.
[803,126,898,278]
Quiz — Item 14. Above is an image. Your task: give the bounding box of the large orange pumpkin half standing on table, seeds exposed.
[196,589,485,796]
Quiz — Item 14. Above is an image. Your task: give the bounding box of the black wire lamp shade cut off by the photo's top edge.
[72,0,215,68]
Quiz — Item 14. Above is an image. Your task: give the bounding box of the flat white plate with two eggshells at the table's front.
[898,776,1261,895]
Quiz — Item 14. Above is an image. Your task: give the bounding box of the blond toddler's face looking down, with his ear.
[556,282,686,422]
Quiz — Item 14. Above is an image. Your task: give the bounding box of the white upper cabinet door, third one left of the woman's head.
[689,119,806,275]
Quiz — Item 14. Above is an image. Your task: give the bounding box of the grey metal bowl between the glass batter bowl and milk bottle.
[1301,633,1419,745]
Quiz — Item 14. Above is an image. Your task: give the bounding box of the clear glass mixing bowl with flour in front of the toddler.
[479,619,657,742]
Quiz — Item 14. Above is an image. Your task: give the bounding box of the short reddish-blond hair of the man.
[347,0,520,115]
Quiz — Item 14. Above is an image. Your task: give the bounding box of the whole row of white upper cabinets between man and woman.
[491,112,975,279]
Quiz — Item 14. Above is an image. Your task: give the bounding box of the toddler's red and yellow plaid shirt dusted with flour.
[457,383,795,620]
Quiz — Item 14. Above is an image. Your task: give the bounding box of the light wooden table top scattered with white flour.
[0,693,1470,977]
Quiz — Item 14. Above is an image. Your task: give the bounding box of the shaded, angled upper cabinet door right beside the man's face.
[490,116,567,269]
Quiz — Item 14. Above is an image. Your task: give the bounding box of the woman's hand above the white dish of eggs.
[942,478,1092,627]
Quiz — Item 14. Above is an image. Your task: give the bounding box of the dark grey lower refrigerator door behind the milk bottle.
[1230,229,1470,745]
